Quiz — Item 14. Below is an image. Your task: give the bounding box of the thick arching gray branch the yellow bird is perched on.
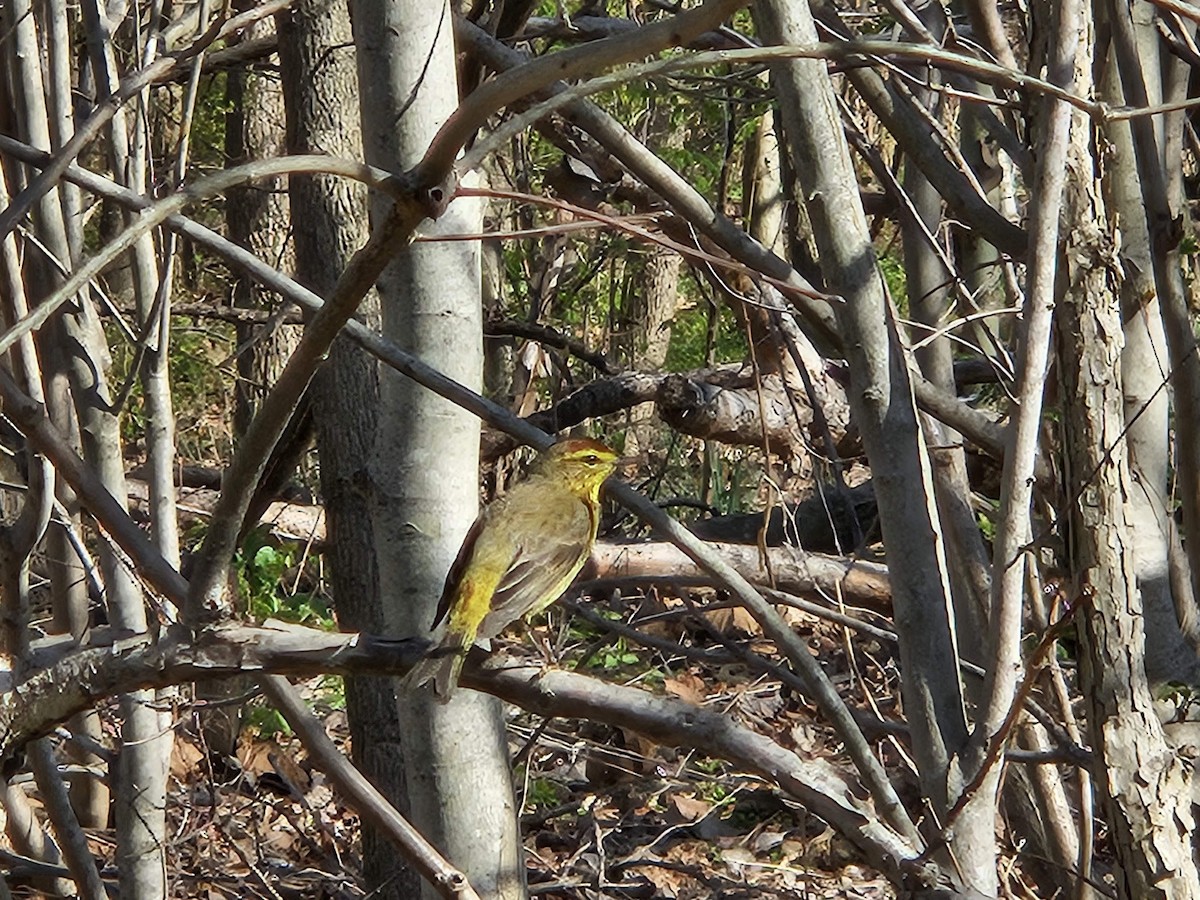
[0,623,916,882]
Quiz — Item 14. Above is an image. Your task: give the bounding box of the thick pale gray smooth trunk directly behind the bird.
[352,0,524,898]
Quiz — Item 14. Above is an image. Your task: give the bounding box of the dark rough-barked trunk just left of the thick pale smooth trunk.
[276,0,418,900]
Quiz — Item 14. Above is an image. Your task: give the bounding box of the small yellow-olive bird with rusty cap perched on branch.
[406,440,618,702]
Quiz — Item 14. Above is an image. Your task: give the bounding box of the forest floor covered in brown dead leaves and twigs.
[65,600,902,900]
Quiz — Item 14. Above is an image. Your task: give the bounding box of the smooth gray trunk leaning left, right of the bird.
[757,0,974,890]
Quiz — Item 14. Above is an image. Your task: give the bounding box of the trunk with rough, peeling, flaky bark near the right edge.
[1056,111,1200,899]
